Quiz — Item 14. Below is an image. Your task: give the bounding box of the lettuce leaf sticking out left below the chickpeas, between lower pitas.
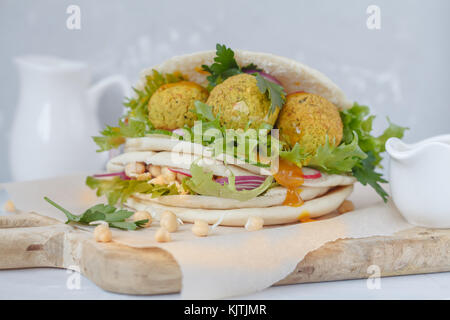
[86,177,179,205]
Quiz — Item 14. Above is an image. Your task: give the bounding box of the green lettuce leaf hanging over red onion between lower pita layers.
[185,163,273,201]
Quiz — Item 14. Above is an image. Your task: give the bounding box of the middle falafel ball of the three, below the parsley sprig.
[206,73,280,129]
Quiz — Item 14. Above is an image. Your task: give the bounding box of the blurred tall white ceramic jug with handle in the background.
[9,55,130,181]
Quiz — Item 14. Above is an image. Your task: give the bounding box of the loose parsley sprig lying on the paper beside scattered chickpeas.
[44,197,148,230]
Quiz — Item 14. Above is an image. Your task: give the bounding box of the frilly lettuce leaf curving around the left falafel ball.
[93,70,186,152]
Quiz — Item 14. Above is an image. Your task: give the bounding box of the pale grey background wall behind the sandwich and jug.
[0,0,450,181]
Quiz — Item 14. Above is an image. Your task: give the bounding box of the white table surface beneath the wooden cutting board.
[0,268,450,300]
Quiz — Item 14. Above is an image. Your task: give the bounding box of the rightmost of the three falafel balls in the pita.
[277,92,343,154]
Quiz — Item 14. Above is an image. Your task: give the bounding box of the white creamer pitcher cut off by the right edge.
[386,135,450,228]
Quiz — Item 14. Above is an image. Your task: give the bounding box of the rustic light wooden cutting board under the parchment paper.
[0,213,450,295]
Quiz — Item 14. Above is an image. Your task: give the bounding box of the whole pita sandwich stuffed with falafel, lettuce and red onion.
[86,45,405,226]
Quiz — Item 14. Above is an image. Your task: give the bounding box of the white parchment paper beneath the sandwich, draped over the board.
[3,175,412,299]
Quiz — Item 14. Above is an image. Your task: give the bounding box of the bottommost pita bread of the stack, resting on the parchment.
[126,185,353,227]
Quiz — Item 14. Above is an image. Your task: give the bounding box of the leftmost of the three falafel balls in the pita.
[148,81,209,130]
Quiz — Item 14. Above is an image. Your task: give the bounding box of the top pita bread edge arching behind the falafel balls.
[136,50,352,109]
